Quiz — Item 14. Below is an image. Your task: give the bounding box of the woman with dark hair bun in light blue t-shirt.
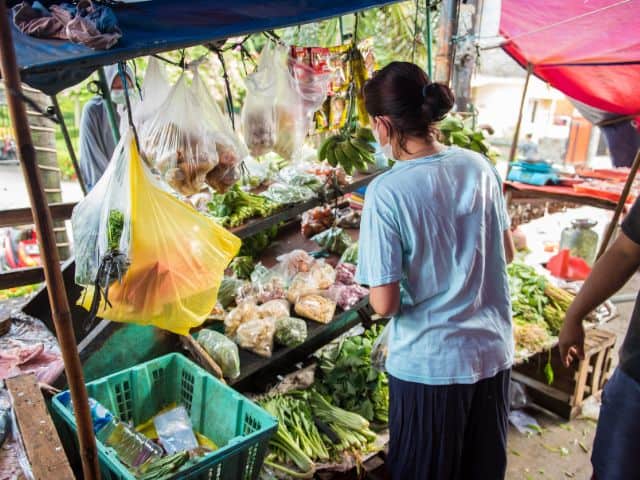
[357,62,514,480]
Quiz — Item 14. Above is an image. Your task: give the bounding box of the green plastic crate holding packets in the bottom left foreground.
[51,353,278,480]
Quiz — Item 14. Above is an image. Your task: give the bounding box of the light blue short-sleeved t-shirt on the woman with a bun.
[356,147,514,385]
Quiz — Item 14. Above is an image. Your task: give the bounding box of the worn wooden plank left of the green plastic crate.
[5,374,75,480]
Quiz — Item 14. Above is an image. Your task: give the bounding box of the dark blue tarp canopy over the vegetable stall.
[11,0,395,95]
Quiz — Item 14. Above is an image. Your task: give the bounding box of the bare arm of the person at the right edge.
[558,233,640,367]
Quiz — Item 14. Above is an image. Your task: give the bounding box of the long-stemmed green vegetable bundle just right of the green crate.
[260,390,376,478]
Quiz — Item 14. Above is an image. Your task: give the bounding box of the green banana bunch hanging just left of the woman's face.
[318,127,376,175]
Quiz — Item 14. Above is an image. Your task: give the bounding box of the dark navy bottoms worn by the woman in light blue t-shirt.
[387,370,511,480]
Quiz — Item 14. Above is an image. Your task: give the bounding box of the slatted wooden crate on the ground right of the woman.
[512,328,616,420]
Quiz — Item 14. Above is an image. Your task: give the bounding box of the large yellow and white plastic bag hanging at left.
[72,131,241,335]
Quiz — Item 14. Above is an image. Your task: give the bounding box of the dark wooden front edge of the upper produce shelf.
[229,169,387,238]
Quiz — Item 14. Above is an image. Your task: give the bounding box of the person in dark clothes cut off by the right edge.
[559,196,640,480]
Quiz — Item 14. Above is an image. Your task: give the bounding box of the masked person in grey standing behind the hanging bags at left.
[79,65,134,190]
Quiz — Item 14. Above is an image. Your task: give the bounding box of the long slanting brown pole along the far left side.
[0,2,100,480]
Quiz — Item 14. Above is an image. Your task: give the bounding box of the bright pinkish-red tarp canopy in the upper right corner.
[500,0,640,115]
